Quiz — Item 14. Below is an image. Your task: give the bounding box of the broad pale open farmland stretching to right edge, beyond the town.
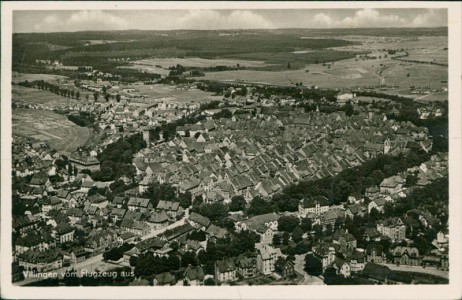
[202,53,448,89]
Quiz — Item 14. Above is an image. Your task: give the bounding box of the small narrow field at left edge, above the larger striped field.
[11,85,82,107]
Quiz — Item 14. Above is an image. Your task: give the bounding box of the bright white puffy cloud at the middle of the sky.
[175,10,274,29]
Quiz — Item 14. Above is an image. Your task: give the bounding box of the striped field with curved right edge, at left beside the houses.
[12,109,91,155]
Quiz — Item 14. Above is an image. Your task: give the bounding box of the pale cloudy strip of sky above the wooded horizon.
[13,8,448,33]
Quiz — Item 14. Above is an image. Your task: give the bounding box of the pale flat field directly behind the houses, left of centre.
[124,84,223,103]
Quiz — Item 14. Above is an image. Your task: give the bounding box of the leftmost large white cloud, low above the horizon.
[34,10,129,32]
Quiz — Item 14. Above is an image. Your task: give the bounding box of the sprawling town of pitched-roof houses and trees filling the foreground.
[12,23,449,286]
